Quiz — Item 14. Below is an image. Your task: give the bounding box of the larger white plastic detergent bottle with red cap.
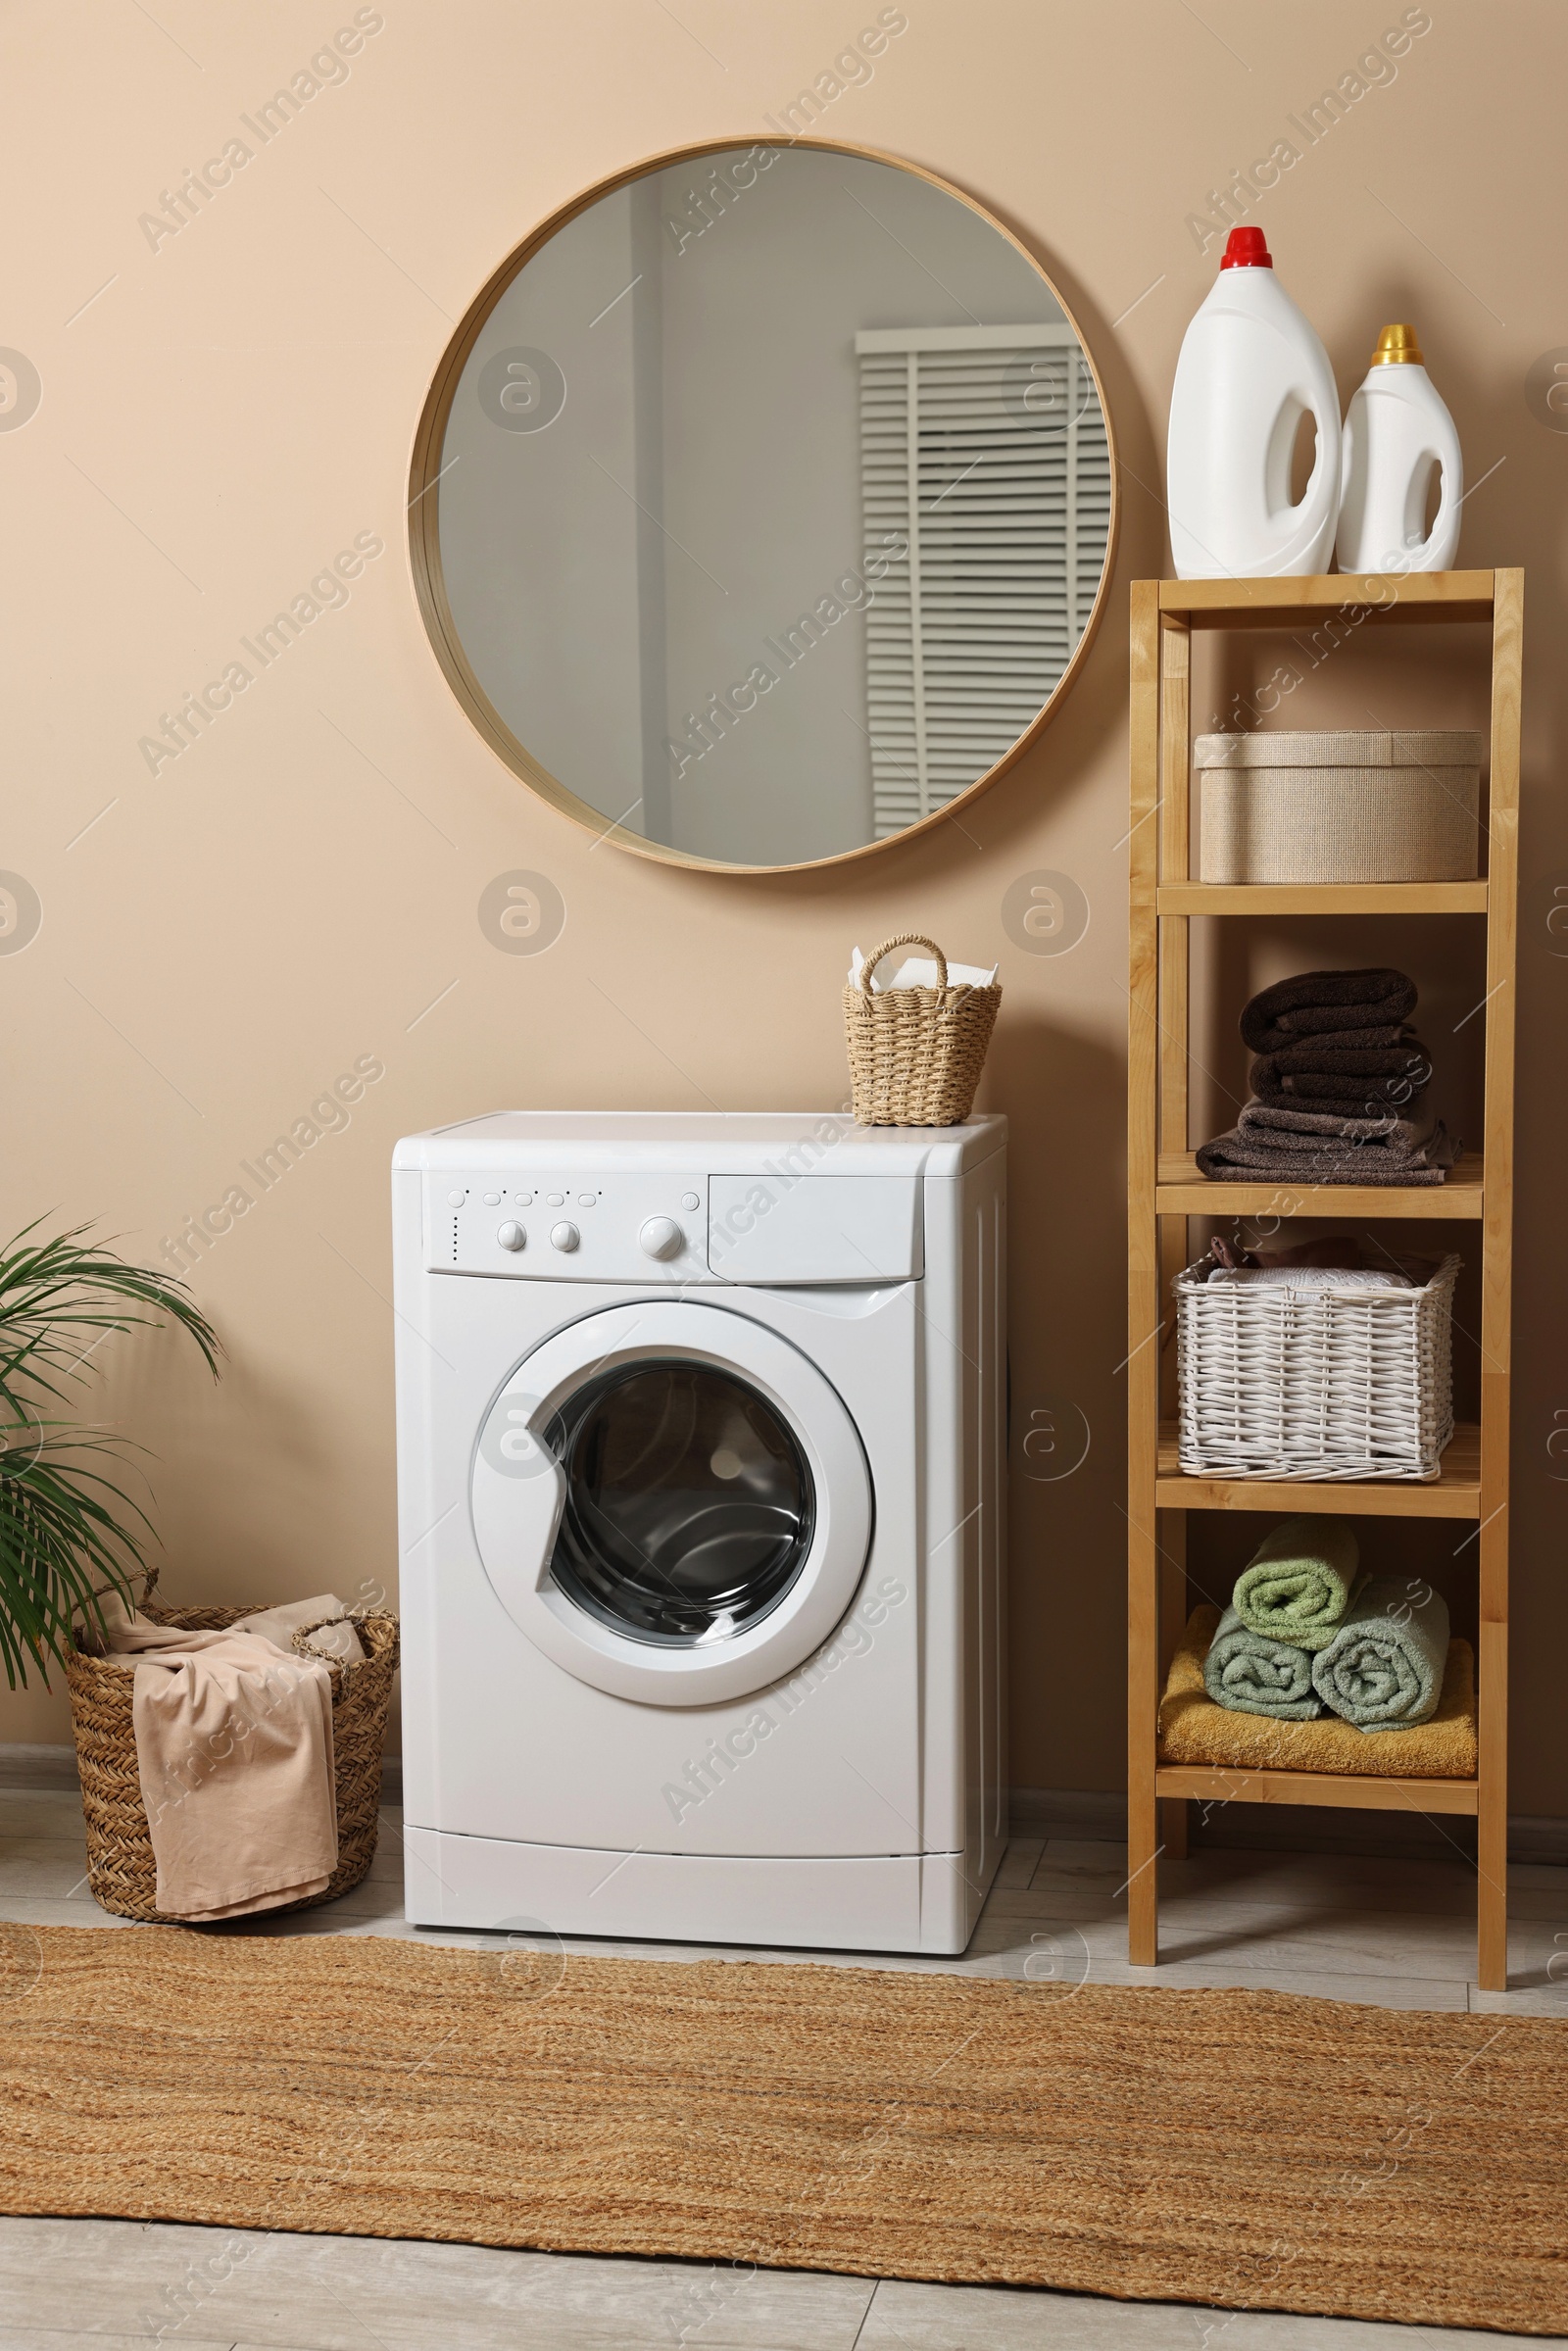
[1166,228,1340,581]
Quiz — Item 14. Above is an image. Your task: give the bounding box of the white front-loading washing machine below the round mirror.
[393,1112,1006,1951]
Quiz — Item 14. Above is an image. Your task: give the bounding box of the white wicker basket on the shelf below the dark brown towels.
[1171,1257,1460,1479]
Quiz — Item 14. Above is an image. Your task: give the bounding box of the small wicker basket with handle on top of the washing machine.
[844,931,1002,1126]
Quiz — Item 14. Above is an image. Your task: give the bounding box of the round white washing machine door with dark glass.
[472,1300,872,1707]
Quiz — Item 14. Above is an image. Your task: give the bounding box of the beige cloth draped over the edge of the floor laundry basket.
[104,1596,343,1919]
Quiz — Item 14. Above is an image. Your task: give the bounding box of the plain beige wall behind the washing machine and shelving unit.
[0,0,1568,1813]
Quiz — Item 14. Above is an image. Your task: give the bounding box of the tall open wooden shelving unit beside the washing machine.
[1126,571,1523,1991]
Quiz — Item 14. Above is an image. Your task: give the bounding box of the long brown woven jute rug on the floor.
[0,1928,1568,2334]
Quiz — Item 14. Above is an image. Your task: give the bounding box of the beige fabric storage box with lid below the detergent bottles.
[1192,726,1481,882]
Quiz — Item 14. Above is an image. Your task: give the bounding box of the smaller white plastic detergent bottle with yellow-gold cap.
[1338,326,1464,573]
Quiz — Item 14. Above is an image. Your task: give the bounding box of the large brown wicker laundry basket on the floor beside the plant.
[66,1571,397,1926]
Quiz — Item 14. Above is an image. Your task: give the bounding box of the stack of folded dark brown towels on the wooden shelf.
[1197,968,1460,1185]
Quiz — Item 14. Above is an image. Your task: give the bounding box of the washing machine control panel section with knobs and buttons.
[425,1168,714,1289]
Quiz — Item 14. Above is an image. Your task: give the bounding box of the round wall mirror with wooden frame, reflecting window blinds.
[409,141,1116,870]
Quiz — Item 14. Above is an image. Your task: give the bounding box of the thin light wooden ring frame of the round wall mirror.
[409,136,1121,874]
